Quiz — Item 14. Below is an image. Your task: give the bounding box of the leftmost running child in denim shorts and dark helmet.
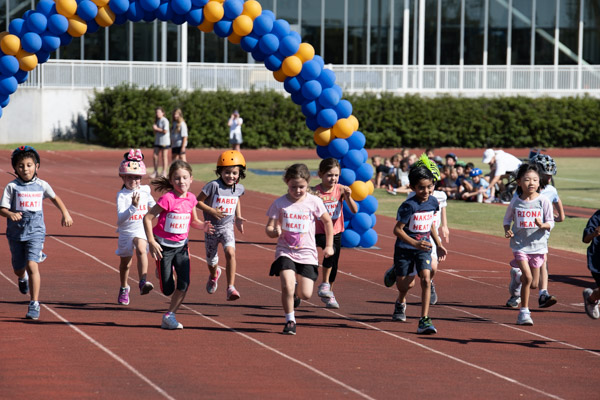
[0,146,73,320]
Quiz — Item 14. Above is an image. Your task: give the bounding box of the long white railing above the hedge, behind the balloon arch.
[17,60,600,97]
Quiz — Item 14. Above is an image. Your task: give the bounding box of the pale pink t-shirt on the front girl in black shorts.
[267,193,327,265]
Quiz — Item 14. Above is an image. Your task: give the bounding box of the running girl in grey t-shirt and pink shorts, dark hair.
[504,163,554,325]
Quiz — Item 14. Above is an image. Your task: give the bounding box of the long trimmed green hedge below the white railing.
[88,86,600,148]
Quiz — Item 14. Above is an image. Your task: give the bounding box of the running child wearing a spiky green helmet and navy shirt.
[385,155,447,334]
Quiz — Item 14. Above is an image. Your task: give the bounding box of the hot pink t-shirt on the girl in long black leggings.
[152,192,198,242]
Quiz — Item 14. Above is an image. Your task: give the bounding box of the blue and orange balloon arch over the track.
[0,0,378,247]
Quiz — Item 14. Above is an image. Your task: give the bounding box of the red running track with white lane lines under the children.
[0,151,600,399]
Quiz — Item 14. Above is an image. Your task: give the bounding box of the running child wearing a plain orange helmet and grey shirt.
[196,150,246,301]
